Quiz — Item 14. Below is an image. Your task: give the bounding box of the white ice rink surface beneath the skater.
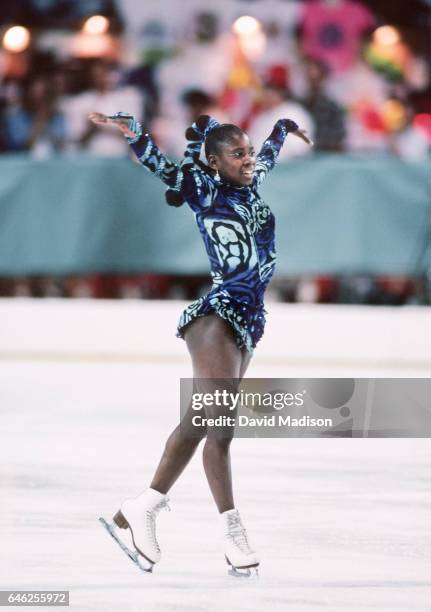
[0,359,431,612]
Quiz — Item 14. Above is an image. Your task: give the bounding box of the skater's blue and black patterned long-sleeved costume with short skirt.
[118,113,297,351]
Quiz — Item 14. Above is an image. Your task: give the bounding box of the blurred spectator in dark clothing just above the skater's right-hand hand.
[304,59,346,151]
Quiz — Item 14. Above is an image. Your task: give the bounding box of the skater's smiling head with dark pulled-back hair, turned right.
[207,126,256,187]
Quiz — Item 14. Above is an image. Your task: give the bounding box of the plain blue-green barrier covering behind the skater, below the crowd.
[0,155,431,276]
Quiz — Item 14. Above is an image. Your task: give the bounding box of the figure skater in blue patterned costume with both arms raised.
[89,113,312,576]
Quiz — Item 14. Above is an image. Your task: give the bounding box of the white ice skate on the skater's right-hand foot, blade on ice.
[220,508,259,578]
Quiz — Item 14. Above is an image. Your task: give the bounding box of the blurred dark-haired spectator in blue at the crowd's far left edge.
[3,75,66,155]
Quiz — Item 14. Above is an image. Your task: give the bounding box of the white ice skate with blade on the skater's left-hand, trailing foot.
[99,489,170,572]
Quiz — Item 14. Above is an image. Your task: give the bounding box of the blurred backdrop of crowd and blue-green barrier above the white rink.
[0,0,431,305]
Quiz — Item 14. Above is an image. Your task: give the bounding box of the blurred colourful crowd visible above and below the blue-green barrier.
[0,0,431,303]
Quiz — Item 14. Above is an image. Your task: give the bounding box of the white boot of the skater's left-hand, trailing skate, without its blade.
[114,489,170,564]
